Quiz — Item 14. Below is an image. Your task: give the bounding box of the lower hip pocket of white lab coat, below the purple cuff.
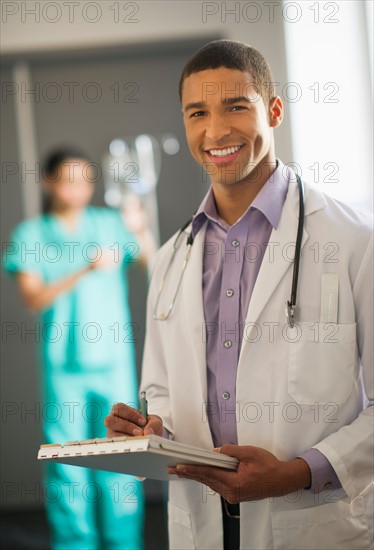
[271,497,371,550]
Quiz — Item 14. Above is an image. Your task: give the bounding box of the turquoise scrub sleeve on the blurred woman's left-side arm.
[2,220,43,275]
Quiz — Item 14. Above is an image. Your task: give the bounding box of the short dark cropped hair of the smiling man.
[179,40,276,106]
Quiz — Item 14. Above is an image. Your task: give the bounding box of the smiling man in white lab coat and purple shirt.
[106,40,373,550]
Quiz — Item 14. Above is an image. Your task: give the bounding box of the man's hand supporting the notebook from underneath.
[168,445,311,504]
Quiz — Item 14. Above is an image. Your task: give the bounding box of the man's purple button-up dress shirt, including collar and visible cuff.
[192,161,341,493]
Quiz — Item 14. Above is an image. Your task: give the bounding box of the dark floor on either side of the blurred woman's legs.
[0,502,168,550]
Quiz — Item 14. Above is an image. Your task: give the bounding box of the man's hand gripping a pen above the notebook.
[104,403,163,437]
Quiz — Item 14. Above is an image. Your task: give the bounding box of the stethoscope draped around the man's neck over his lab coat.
[153,175,304,328]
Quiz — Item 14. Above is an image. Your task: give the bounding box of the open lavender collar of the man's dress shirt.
[192,159,289,237]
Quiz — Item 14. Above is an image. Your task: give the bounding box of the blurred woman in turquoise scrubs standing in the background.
[5,150,152,550]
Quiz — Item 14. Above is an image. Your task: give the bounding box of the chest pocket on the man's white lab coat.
[288,322,357,405]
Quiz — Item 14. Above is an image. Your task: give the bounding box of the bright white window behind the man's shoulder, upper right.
[283,0,373,209]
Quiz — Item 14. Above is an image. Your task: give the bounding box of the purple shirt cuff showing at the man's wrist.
[298,449,342,494]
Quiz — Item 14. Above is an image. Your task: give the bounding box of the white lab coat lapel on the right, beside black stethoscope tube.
[242,178,309,344]
